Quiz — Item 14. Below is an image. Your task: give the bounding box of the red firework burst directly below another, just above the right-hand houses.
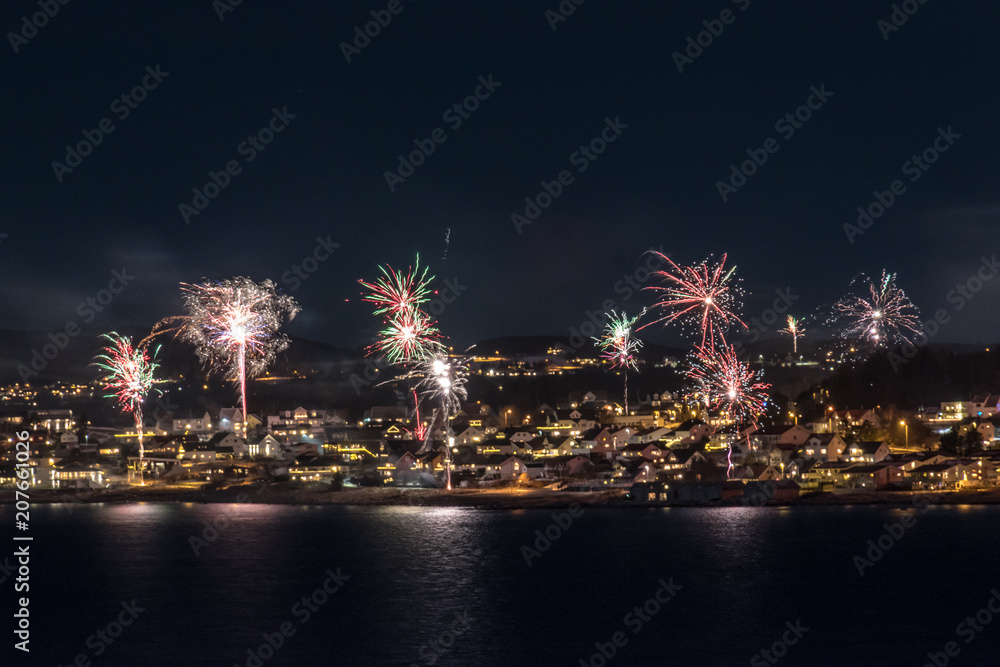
[687,345,771,475]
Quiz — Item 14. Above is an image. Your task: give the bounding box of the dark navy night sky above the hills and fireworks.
[0,0,1000,345]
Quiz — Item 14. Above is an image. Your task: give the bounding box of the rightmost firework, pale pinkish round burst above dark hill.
[833,270,921,348]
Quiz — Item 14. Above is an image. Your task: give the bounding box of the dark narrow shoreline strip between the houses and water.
[0,485,1000,510]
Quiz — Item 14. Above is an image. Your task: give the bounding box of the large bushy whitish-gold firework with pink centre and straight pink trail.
[146,276,301,435]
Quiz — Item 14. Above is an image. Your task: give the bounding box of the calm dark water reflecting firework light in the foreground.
[0,504,1000,667]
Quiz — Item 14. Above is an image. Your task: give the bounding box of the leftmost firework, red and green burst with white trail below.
[93,332,159,485]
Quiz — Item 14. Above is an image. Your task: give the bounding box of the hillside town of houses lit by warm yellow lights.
[0,349,1000,504]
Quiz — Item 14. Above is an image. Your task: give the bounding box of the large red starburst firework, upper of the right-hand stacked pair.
[639,251,746,347]
